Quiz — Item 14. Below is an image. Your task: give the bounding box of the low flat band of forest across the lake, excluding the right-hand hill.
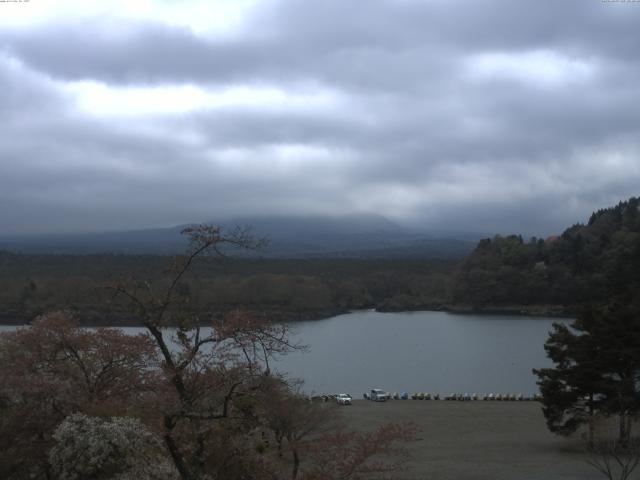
[0,252,456,324]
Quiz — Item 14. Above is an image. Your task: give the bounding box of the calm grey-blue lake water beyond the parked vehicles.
[0,311,563,397]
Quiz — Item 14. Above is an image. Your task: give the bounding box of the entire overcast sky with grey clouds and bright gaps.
[0,0,640,235]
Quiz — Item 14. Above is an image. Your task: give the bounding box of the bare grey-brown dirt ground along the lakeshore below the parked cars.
[340,400,604,480]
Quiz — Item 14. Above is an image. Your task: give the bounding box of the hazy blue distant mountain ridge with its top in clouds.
[0,214,474,259]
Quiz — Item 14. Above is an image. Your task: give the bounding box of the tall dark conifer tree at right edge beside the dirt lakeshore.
[534,302,640,443]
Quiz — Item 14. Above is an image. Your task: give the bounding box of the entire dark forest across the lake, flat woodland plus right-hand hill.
[0,198,640,324]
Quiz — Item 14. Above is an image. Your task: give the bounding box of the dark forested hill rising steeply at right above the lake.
[451,198,640,313]
